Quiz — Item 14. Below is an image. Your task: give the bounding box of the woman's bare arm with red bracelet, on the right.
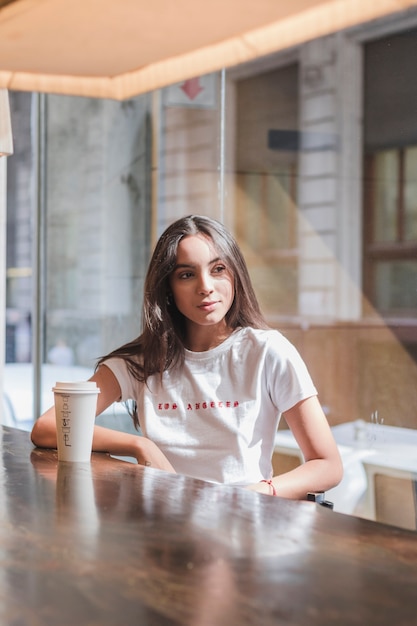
[248,396,343,500]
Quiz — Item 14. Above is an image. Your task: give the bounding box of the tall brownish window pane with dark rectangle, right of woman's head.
[234,64,300,322]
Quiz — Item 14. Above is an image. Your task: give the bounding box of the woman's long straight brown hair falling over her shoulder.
[97,215,268,420]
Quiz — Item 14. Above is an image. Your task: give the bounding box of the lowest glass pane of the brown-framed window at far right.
[375,261,417,313]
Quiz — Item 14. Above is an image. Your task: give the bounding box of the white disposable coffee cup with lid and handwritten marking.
[52,381,100,463]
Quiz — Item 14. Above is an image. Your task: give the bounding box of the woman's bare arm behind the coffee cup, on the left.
[31,365,175,472]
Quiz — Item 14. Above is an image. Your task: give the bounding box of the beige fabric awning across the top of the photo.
[0,0,417,100]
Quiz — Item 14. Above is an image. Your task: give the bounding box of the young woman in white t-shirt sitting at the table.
[32,216,342,499]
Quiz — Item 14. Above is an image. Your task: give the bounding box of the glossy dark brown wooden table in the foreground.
[0,427,417,626]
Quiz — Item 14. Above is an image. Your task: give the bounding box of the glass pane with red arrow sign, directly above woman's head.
[154,73,224,229]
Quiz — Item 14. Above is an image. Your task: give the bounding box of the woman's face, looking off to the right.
[170,235,235,326]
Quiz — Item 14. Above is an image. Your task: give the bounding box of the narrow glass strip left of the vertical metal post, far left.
[0,93,33,430]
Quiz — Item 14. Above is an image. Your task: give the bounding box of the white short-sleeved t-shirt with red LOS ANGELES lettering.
[105,328,317,484]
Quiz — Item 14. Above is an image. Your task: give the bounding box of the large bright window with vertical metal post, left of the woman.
[4,93,152,430]
